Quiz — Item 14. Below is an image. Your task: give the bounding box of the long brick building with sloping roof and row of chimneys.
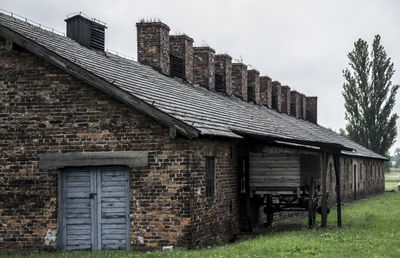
[0,14,386,251]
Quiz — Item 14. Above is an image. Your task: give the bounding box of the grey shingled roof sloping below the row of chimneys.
[0,13,386,159]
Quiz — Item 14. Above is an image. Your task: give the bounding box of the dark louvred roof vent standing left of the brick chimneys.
[65,12,107,51]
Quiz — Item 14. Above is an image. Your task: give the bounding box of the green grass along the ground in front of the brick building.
[4,173,400,258]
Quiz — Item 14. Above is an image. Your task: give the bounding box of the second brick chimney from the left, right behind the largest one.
[169,35,193,83]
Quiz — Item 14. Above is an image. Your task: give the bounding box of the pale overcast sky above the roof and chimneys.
[0,0,400,154]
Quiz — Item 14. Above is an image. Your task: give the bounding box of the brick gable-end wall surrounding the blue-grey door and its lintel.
[0,41,197,251]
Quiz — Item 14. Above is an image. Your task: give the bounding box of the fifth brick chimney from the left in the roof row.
[232,63,247,101]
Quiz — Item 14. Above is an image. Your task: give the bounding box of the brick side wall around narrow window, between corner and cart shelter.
[190,139,240,248]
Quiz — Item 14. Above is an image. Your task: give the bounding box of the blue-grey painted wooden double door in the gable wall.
[59,166,130,251]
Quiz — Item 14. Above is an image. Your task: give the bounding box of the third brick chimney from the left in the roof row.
[193,47,215,91]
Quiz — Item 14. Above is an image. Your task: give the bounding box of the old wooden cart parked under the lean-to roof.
[246,152,321,228]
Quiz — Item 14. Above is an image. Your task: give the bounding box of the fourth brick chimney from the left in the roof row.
[215,54,232,96]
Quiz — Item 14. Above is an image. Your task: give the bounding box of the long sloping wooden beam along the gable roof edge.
[0,25,199,139]
